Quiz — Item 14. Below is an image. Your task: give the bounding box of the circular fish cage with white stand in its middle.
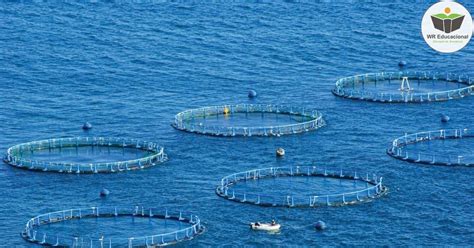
[332,71,474,103]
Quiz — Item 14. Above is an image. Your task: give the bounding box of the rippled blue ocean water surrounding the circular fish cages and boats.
[0,1,474,247]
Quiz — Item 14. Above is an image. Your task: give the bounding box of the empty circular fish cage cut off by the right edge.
[387,129,474,166]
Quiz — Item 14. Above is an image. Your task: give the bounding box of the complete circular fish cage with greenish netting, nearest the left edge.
[4,137,168,174]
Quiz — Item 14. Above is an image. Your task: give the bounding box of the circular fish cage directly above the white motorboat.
[216,166,388,208]
